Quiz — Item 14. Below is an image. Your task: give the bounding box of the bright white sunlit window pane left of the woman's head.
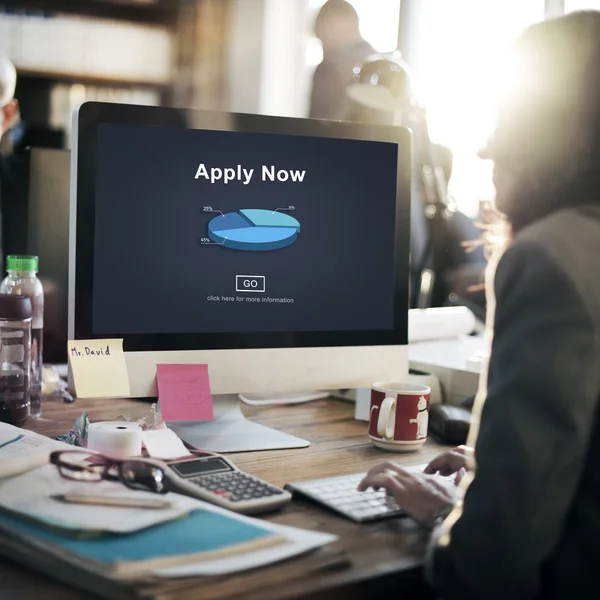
[411,0,544,216]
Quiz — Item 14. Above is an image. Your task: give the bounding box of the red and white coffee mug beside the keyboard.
[369,381,431,452]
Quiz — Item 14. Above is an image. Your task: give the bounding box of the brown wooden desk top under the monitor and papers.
[0,400,450,600]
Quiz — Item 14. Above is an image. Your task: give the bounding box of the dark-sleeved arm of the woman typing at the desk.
[431,242,600,600]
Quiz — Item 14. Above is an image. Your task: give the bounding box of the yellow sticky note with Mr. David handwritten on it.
[68,340,129,398]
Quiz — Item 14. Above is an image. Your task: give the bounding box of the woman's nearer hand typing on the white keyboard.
[358,462,456,527]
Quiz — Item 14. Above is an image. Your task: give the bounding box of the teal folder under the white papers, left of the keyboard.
[0,509,286,580]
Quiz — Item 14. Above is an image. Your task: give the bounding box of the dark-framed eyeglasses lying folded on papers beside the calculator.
[50,450,169,494]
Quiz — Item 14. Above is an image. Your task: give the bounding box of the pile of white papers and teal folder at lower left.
[0,422,336,598]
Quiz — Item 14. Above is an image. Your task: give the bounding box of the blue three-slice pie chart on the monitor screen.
[208,208,300,252]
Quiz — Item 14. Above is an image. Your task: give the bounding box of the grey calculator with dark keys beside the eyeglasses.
[166,453,292,514]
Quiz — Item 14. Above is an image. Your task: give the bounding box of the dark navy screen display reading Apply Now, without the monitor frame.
[93,123,398,335]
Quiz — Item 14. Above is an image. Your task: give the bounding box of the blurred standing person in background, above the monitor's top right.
[309,0,374,121]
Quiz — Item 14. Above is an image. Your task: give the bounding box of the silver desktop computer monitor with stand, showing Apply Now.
[69,103,411,451]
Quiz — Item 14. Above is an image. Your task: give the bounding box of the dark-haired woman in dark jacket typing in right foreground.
[360,11,600,600]
